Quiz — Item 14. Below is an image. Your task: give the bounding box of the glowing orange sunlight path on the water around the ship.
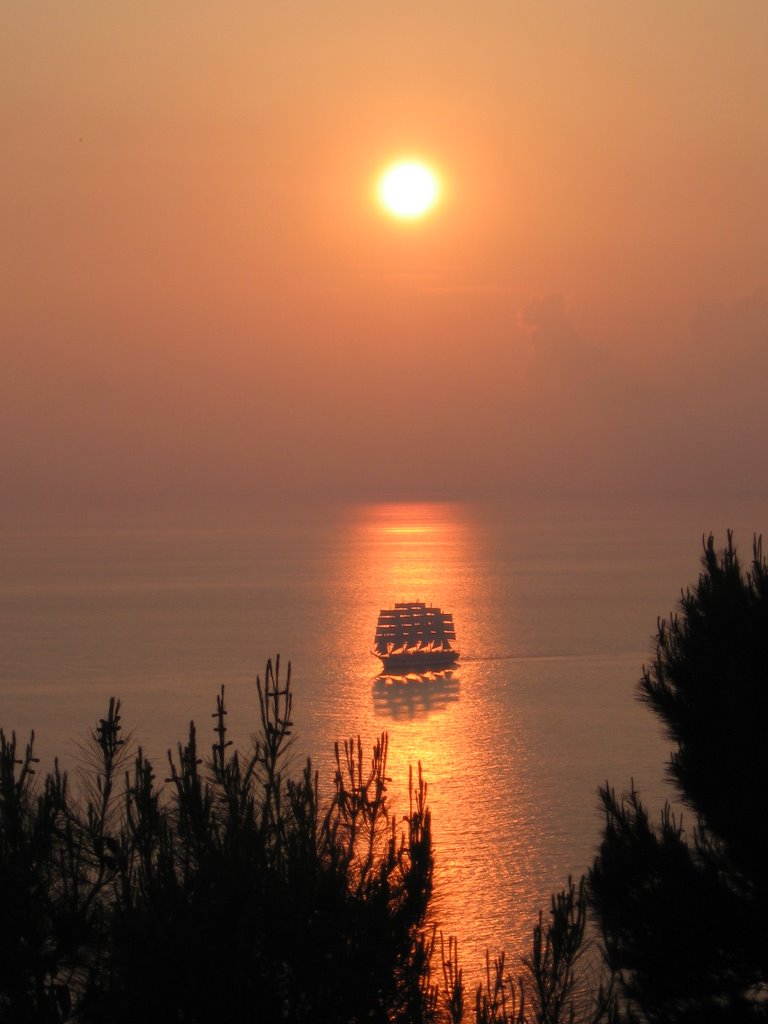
[315,504,542,977]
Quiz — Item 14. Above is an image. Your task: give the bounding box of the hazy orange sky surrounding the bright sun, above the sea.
[0,0,768,509]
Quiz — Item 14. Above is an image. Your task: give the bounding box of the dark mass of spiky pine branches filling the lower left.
[0,664,432,1024]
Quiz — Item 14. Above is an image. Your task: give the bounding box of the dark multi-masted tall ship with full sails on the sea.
[373,601,459,673]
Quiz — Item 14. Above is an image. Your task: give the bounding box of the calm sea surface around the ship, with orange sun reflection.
[0,500,765,977]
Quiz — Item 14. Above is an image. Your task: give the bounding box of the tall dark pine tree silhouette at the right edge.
[590,532,768,1022]
